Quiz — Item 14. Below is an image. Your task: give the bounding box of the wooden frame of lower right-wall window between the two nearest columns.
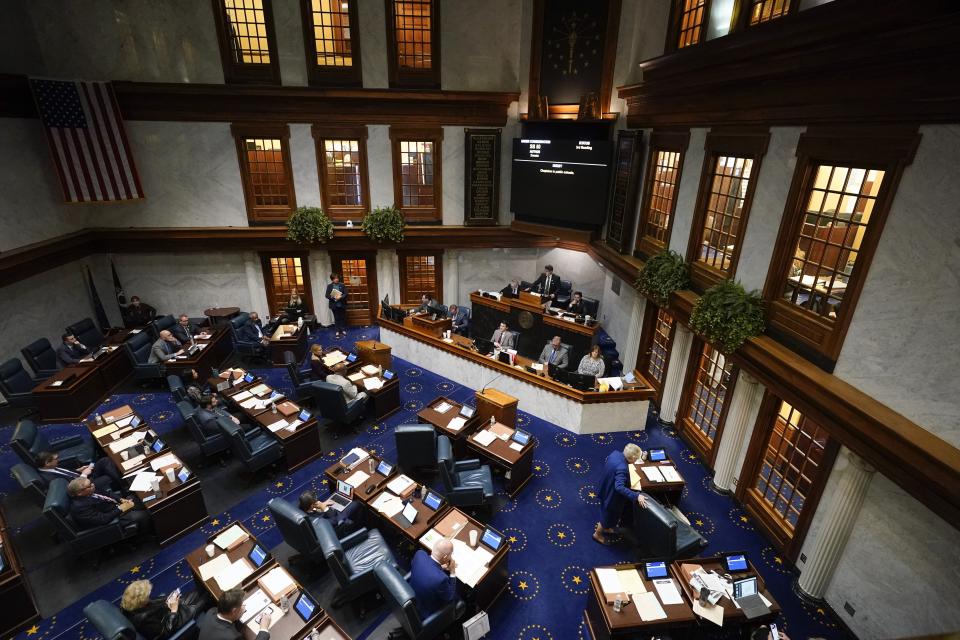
[736,390,840,561]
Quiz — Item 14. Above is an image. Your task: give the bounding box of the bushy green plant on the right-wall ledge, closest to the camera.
[690,280,766,354]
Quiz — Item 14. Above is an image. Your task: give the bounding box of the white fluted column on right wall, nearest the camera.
[797,447,876,600]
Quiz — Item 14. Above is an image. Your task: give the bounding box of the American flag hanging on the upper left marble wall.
[30,78,143,202]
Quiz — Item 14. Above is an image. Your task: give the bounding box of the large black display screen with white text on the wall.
[510,138,613,228]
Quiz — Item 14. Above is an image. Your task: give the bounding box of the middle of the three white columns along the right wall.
[713,370,764,491]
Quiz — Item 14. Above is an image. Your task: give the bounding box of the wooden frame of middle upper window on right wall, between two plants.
[687,128,770,291]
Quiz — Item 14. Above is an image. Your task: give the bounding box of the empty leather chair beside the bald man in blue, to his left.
[313,518,397,608]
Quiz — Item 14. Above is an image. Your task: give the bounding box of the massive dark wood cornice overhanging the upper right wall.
[618,0,960,128]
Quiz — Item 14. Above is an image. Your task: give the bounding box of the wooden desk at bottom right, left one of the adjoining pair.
[584,563,692,640]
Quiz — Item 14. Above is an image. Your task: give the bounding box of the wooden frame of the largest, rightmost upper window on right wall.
[763,126,920,364]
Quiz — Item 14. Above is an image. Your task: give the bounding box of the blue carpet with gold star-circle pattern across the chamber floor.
[0,327,847,640]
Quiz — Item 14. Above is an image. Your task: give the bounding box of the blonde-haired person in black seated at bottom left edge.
[120,580,203,640]
